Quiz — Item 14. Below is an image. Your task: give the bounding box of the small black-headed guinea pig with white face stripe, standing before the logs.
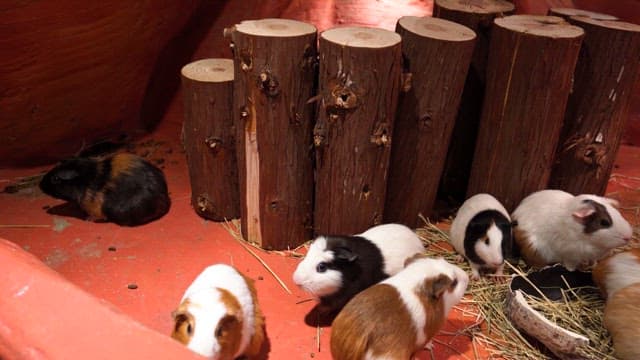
[449,194,513,280]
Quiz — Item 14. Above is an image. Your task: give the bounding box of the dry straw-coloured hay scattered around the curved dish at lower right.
[416,219,620,360]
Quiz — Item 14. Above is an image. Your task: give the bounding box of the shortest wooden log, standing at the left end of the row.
[181,59,240,221]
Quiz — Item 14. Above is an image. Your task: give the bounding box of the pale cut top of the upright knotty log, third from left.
[321,27,401,49]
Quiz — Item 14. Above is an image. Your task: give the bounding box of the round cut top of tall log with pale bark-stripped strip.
[235,19,316,37]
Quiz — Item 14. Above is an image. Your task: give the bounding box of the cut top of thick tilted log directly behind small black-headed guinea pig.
[495,15,584,38]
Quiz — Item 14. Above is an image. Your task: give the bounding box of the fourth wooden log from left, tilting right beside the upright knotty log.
[384,16,476,228]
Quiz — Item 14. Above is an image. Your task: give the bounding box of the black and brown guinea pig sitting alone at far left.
[40,153,171,226]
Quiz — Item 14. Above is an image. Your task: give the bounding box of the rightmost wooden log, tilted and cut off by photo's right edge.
[549,16,640,195]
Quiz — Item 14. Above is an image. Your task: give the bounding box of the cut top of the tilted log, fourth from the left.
[398,16,476,41]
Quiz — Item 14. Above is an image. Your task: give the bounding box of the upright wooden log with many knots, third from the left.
[313,27,402,234]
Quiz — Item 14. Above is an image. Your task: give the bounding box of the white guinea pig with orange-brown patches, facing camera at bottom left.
[171,264,265,360]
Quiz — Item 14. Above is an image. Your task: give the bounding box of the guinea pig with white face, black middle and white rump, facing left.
[293,224,424,313]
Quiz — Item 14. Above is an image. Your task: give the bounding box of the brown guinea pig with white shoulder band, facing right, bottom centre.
[331,254,469,360]
